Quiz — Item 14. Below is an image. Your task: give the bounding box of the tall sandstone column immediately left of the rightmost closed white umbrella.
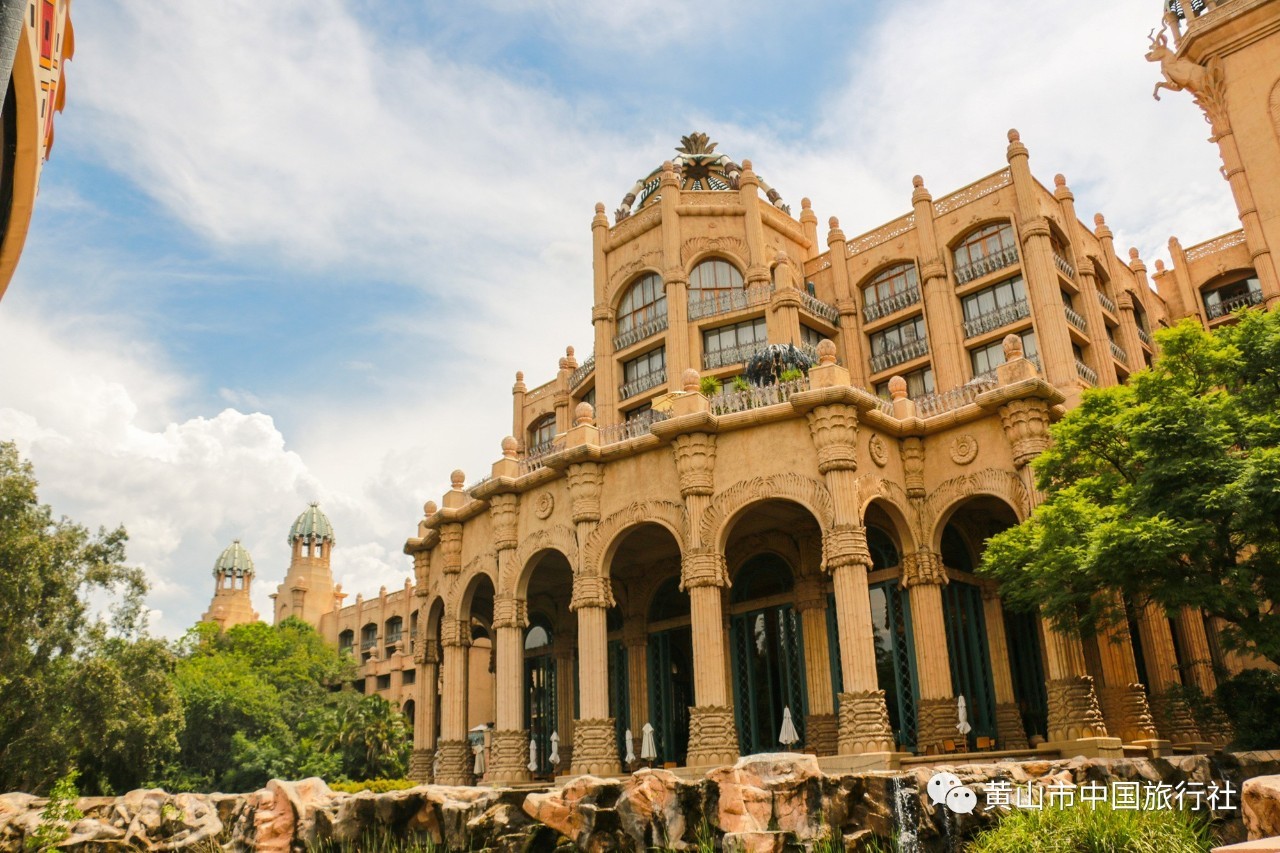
[901,551,960,753]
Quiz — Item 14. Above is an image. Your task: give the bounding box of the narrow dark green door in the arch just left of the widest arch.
[650,625,694,765]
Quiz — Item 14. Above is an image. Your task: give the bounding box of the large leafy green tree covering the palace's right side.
[982,311,1280,663]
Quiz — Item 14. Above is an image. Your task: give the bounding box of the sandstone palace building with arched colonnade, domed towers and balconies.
[210,0,1280,784]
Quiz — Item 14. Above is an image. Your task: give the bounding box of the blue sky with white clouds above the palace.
[0,0,1238,635]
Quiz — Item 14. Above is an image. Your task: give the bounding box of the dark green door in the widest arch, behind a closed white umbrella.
[730,605,808,756]
